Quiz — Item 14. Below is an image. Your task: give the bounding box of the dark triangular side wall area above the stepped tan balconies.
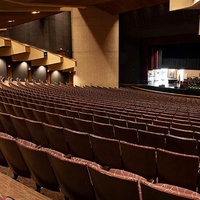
[0,12,72,57]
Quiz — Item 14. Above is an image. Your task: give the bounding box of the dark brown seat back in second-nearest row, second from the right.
[120,142,157,180]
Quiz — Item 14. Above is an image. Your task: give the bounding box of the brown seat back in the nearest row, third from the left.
[46,149,95,200]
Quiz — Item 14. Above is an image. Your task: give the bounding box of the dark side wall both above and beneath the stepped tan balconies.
[0,12,72,83]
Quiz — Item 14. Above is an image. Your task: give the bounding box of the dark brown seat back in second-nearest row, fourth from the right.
[64,128,94,161]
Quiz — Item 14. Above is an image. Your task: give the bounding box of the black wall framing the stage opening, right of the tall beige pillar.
[119,3,200,84]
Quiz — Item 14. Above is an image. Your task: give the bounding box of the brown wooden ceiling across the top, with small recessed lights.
[0,0,169,28]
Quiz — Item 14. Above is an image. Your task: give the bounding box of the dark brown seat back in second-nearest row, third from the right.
[90,134,122,169]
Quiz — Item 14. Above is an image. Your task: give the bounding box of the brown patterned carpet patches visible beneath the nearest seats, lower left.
[0,166,64,200]
